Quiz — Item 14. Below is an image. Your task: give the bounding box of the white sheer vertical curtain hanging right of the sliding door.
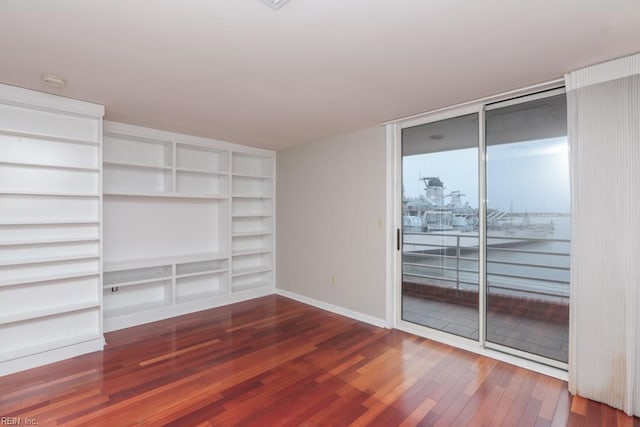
[566,54,640,415]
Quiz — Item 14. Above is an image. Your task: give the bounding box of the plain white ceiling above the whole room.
[0,0,640,149]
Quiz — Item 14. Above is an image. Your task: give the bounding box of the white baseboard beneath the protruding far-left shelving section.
[0,337,104,376]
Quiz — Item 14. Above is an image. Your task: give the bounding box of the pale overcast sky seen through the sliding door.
[402,137,570,212]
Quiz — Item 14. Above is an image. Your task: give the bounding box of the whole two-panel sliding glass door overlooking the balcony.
[400,90,570,366]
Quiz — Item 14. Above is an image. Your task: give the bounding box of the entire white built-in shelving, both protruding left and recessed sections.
[0,85,275,375]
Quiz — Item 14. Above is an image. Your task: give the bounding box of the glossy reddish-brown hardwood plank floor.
[0,296,640,426]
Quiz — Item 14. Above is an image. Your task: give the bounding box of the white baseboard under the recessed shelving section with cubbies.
[104,286,274,332]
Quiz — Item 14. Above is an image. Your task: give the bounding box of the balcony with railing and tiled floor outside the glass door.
[402,232,570,362]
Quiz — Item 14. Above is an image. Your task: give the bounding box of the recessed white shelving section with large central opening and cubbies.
[103,122,275,330]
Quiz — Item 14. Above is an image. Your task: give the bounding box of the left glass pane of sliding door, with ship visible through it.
[401,114,479,340]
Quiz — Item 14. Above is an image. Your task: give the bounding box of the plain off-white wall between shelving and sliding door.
[276,126,386,320]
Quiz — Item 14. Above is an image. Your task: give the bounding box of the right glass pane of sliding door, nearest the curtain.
[485,94,570,362]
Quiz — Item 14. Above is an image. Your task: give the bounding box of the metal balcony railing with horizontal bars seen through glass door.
[402,232,570,300]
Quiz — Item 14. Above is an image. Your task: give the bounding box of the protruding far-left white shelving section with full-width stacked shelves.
[0,85,104,375]
